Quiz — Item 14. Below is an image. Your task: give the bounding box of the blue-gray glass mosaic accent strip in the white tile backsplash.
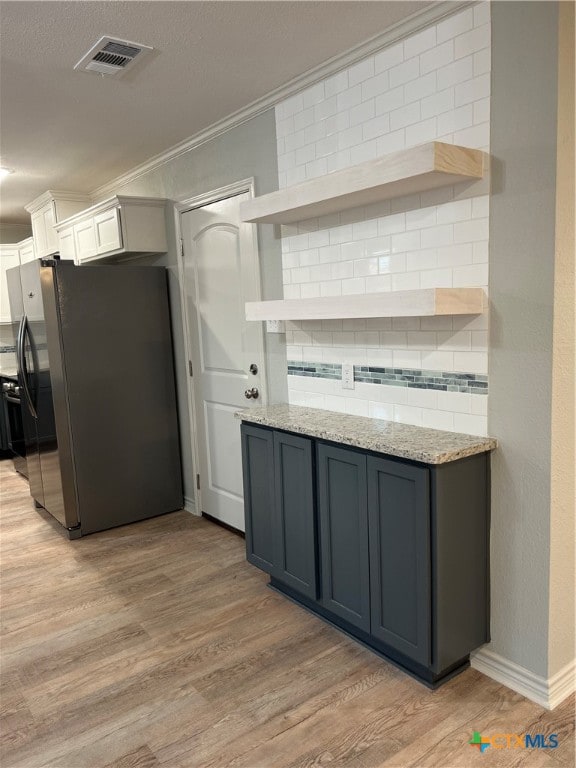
[288,360,488,395]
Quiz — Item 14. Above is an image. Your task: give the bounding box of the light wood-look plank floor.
[0,461,574,768]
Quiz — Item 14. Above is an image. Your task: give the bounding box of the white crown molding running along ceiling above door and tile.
[91,0,478,200]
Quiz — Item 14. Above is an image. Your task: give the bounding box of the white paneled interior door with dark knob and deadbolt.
[181,192,266,531]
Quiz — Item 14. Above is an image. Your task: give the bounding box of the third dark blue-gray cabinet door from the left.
[318,443,370,632]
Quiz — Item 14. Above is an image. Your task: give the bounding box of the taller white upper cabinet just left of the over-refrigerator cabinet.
[26,190,92,258]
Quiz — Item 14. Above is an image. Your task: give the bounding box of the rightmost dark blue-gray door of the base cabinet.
[368,456,431,665]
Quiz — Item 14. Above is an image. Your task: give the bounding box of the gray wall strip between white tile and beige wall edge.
[488,2,558,676]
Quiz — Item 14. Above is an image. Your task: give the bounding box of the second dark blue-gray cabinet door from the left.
[274,432,318,600]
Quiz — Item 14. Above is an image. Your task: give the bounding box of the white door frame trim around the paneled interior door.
[174,177,268,517]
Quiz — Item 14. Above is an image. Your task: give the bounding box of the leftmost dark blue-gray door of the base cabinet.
[242,424,275,574]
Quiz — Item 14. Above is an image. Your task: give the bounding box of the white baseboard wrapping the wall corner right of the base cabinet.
[470,649,576,709]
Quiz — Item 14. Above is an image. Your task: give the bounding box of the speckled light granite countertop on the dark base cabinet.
[235,404,498,464]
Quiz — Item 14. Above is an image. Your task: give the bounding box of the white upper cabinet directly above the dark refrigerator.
[56,196,168,264]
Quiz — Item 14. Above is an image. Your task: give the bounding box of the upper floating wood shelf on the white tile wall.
[240,141,488,224]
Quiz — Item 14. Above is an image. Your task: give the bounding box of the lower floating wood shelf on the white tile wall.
[246,288,486,320]
